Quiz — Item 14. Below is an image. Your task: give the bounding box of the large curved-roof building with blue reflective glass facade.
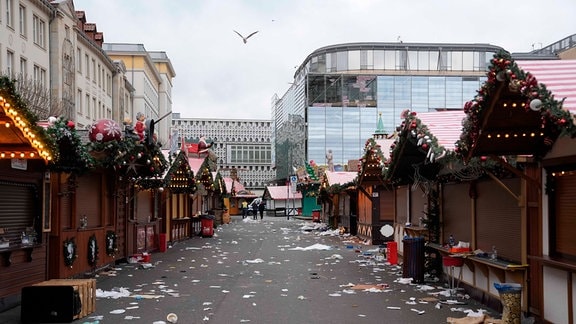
[272,43,502,178]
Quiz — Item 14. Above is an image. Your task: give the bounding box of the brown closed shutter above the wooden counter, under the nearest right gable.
[476,178,522,262]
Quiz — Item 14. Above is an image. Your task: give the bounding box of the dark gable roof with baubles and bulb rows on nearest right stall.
[456,51,576,161]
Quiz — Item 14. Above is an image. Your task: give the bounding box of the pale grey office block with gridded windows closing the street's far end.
[172,113,276,194]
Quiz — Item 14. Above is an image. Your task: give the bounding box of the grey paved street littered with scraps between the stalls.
[0,216,500,323]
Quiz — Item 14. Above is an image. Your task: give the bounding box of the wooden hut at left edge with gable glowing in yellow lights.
[0,77,55,309]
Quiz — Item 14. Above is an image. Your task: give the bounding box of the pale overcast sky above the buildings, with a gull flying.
[74,0,576,119]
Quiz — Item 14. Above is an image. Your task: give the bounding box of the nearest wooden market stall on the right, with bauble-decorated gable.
[448,52,576,323]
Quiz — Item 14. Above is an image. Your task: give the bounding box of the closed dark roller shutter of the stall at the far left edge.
[0,182,38,243]
